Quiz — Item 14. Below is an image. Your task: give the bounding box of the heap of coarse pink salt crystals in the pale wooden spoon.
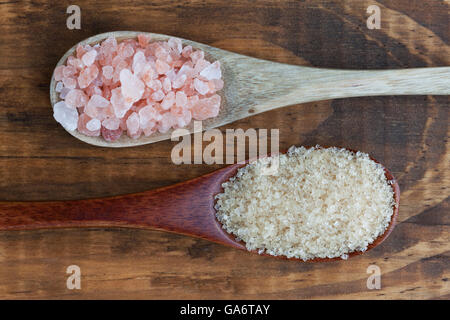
[54,34,223,142]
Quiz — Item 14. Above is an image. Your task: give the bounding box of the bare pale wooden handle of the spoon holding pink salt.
[227,58,450,118]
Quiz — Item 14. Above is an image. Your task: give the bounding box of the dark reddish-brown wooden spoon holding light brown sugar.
[0,150,400,262]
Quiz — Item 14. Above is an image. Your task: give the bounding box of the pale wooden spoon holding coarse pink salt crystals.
[50,31,450,147]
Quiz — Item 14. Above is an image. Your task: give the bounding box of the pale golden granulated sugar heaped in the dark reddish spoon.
[215,147,394,260]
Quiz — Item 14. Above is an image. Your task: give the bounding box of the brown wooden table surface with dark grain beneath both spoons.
[0,0,450,299]
